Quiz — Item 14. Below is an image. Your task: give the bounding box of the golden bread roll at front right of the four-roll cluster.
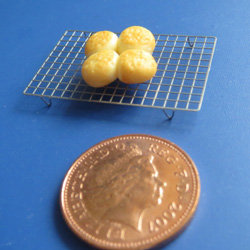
[118,49,157,83]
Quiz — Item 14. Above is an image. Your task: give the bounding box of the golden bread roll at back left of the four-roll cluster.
[85,31,118,57]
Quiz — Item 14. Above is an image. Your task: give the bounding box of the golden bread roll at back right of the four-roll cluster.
[117,26,155,54]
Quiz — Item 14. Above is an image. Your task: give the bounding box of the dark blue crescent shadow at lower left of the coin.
[53,189,97,250]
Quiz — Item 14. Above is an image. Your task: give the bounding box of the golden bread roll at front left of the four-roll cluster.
[81,50,119,88]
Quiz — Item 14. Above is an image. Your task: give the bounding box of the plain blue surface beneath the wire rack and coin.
[0,0,250,250]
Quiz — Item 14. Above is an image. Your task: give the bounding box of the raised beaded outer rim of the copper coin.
[60,134,200,249]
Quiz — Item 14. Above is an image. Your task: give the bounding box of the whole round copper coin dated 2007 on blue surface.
[61,134,200,249]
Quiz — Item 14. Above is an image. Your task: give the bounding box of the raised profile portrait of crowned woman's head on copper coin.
[84,146,167,231]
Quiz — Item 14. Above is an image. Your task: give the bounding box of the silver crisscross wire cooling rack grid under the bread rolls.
[24,30,216,111]
